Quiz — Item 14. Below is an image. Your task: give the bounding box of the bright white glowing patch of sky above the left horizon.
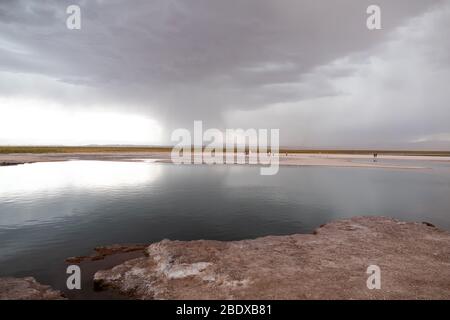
[0,98,161,145]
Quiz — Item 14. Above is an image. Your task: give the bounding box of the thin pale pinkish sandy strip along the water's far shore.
[0,152,450,169]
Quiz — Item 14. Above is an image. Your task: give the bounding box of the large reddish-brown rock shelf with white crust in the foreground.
[94,217,450,299]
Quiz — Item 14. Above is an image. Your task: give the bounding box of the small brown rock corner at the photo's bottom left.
[0,277,64,300]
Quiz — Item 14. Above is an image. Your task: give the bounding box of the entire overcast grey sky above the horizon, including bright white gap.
[0,0,450,149]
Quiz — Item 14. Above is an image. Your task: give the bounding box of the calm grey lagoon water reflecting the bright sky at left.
[0,161,450,294]
